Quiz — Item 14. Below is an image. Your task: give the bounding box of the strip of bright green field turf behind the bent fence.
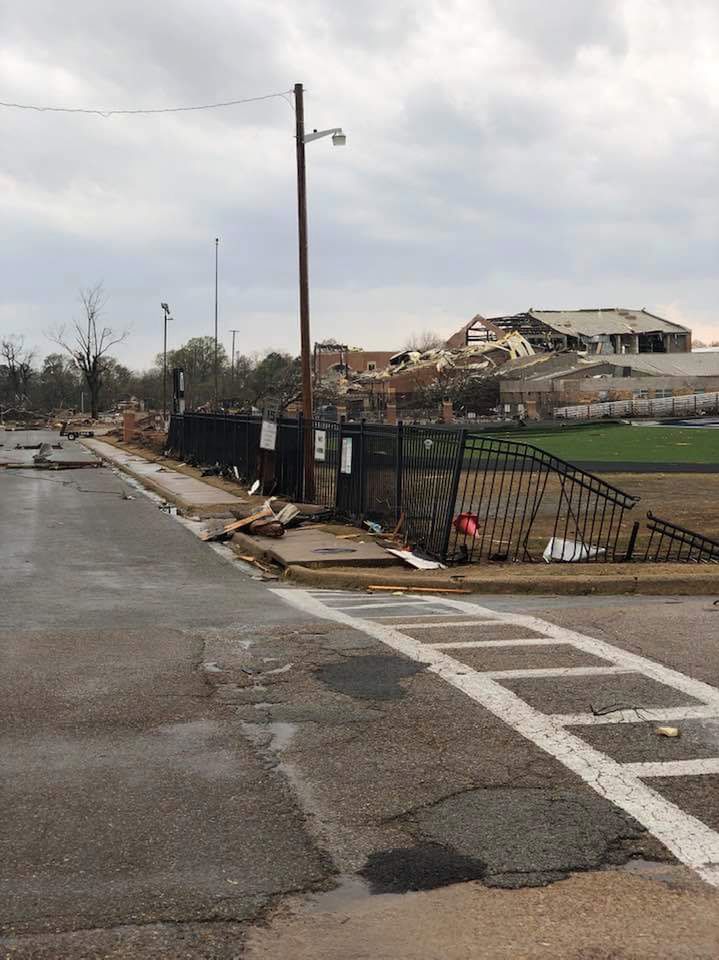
[490,424,719,463]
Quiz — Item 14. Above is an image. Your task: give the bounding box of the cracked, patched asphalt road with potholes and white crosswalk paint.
[0,438,719,960]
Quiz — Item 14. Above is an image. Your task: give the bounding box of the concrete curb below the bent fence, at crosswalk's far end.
[284,565,719,597]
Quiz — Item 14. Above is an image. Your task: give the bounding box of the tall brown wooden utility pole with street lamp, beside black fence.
[294,83,347,497]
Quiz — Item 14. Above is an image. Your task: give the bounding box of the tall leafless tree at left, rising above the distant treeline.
[48,283,128,419]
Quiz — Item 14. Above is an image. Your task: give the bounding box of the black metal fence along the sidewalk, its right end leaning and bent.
[168,413,676,563]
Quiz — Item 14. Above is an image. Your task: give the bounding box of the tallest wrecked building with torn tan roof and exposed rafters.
[448,307,692,356]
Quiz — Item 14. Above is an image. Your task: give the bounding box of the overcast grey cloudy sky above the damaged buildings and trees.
[0,0,719,367]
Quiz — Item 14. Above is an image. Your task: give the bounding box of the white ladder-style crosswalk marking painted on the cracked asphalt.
[273,589,719,886]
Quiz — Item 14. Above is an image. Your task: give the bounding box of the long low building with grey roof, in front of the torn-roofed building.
[496,352,719,419]
